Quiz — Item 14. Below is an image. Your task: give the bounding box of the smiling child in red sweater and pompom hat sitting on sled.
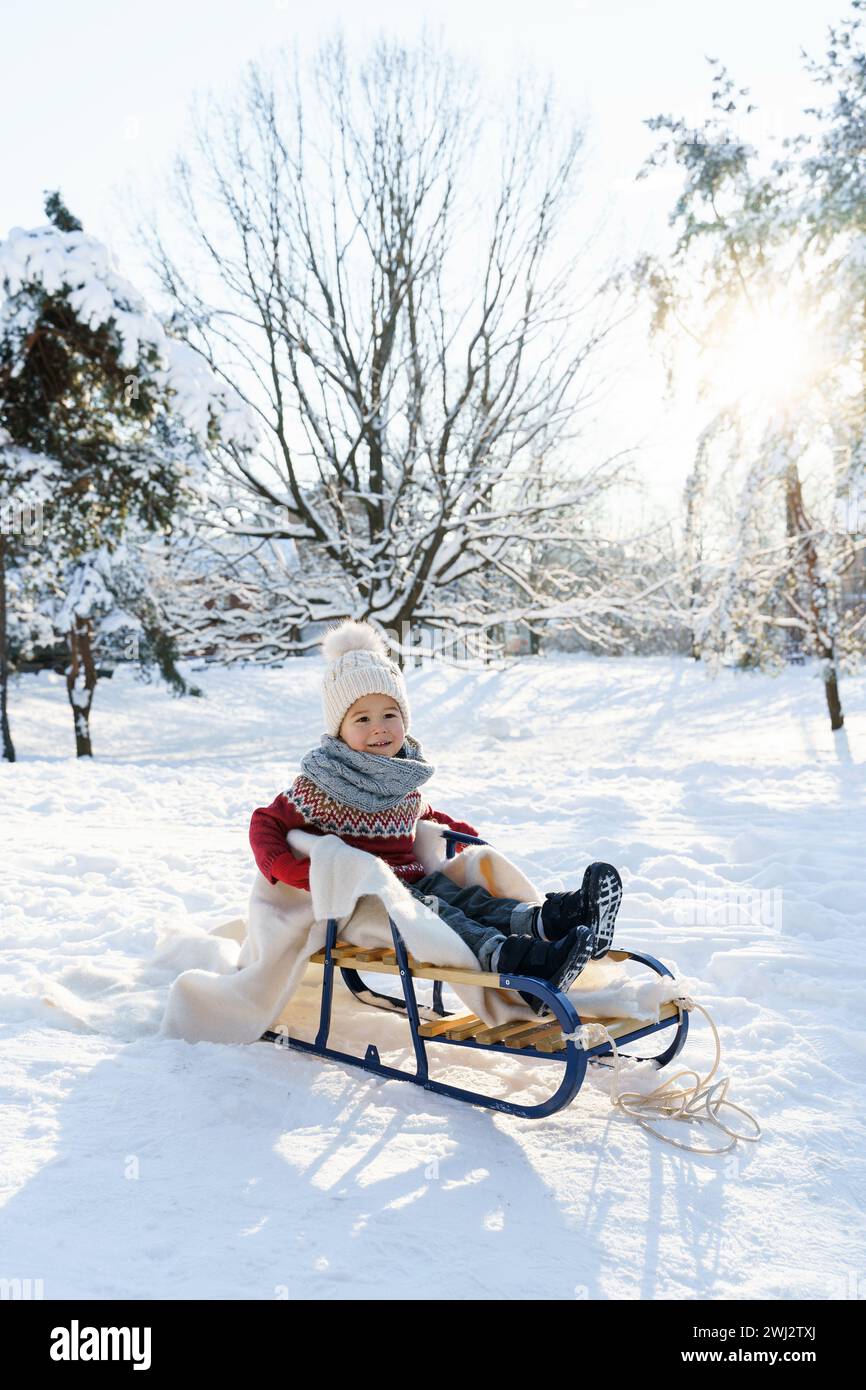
[250,621,623,1012]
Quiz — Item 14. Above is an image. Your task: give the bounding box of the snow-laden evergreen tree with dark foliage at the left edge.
[0,193,256,756]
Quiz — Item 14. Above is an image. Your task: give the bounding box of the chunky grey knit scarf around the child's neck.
[300,734,435,810]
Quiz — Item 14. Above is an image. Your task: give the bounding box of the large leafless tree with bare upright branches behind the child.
[146,27,631,653]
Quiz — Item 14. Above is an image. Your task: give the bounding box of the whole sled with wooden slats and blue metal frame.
[261,830,688,1119]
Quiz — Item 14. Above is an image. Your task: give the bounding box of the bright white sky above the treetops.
[0,0,848,522]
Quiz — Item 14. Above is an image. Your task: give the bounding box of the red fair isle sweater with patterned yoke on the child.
[250,774,478,892]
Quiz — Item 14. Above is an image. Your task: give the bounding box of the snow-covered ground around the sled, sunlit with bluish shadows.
[0,657,866,1300]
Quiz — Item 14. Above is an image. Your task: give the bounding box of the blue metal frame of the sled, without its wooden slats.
[261,830,688,1119]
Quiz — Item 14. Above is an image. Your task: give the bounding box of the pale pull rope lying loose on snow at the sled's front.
[566,995,760,1154]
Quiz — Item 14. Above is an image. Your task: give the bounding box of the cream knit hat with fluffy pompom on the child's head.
[321,619,409,738]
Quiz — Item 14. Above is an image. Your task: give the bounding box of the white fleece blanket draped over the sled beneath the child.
[160,821,681,1043]
